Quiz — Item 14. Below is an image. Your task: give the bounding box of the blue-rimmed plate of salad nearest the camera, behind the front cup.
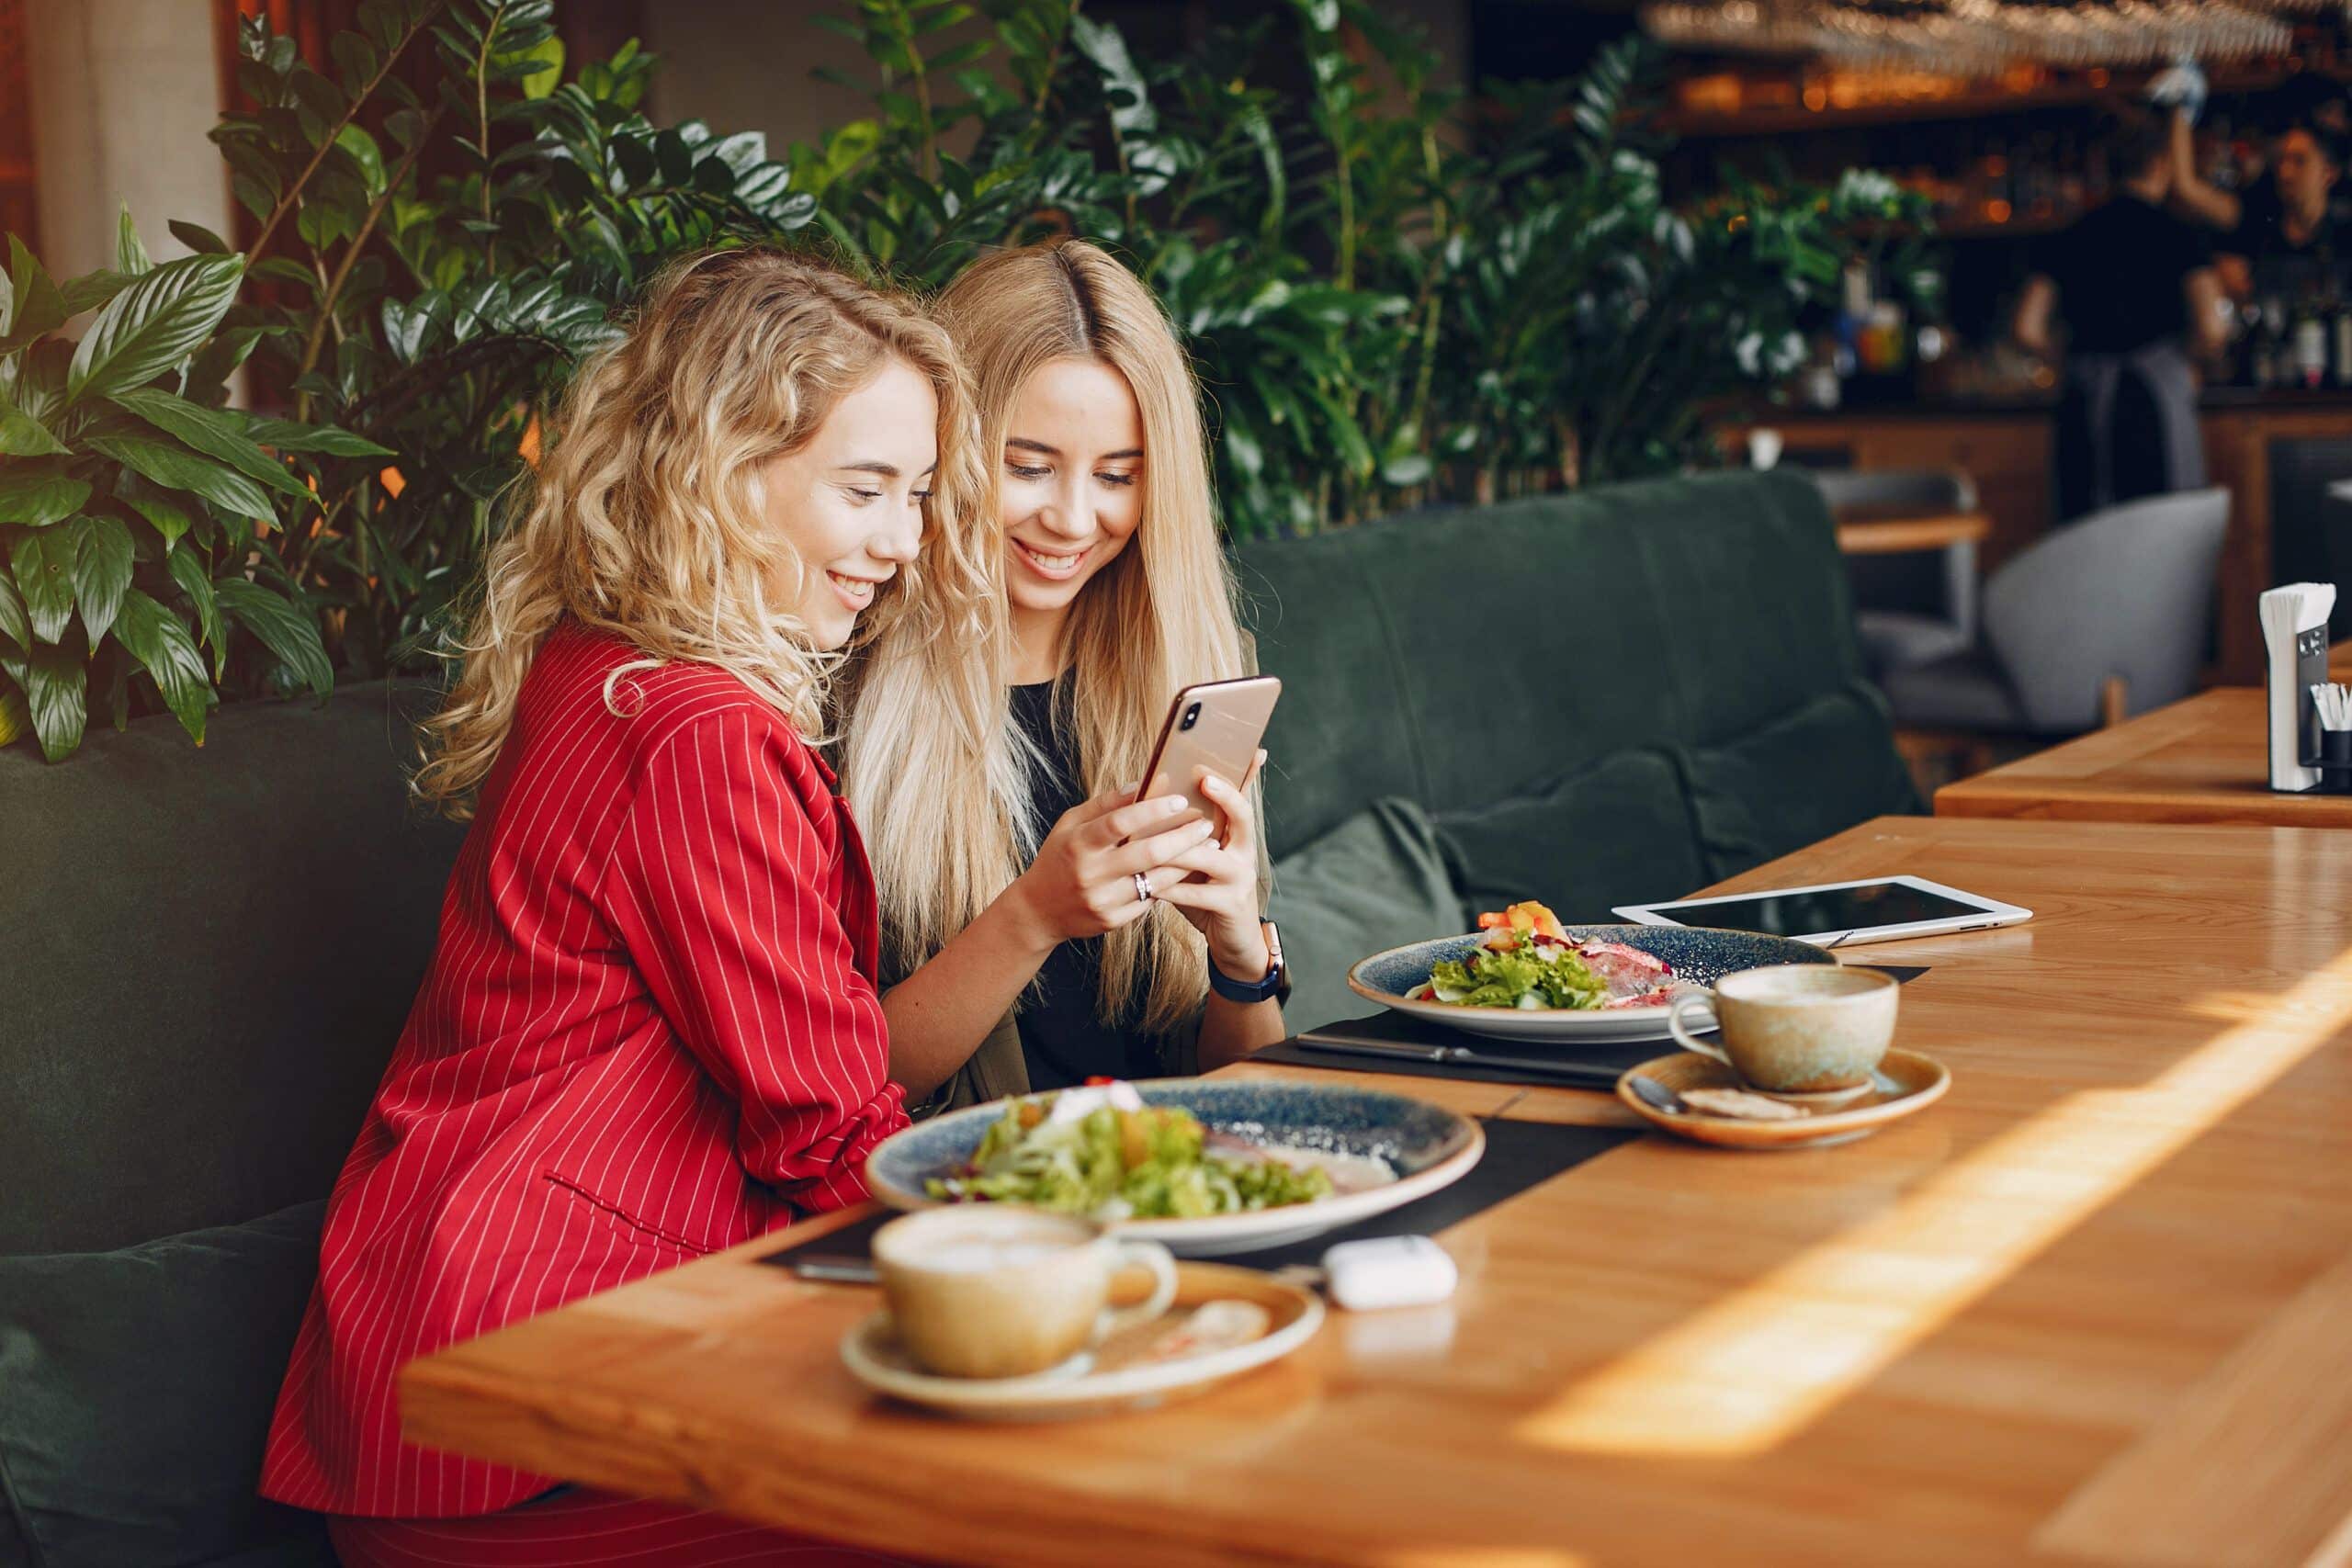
[865,1079,1487,1258]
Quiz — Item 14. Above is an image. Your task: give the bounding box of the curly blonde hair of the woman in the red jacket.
[414,247,1004,818]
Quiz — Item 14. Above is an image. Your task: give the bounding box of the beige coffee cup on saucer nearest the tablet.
[1665,964,1903,1098]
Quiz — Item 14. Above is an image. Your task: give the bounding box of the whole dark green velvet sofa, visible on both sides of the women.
[0,475,1917,1568]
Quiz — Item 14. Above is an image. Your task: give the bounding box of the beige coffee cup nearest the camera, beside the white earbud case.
[873,1203,1176,1378]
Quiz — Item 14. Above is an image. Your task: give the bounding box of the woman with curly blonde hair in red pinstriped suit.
[261,249,1002,1563]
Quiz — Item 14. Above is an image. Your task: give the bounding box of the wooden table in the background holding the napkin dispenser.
[1936,686,2352,828]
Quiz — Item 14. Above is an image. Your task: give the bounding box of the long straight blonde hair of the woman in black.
[842,240,1244,1032]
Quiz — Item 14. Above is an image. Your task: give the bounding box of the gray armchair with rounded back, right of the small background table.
[1879,489,2230,736]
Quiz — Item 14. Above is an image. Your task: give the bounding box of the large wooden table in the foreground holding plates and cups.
[402,818,2352,1568]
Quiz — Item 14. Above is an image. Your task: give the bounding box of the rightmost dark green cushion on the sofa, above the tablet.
[1684,682,1919,879]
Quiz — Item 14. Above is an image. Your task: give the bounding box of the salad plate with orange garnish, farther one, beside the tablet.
[1348,903,1837,1043]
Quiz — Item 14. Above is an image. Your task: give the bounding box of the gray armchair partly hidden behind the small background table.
[1809,468,1975,680]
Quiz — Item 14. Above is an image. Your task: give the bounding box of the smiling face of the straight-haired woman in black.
[997,360,1143,621]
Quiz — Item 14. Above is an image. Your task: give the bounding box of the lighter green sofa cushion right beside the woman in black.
[1268,799,1463,1034]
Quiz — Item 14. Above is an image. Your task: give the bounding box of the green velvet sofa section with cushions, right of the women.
[1238,475,1919,1027]
